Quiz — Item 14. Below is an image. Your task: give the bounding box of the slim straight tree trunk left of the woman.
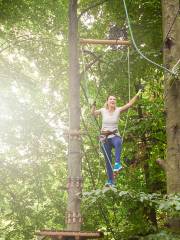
[67,0,81,231]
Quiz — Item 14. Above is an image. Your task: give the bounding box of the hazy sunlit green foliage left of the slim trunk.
[0,1,68,240]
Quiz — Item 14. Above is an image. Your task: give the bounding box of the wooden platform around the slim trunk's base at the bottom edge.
[36,230,103,240]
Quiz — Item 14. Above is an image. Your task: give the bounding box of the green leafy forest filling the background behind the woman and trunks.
[0,0,180,240]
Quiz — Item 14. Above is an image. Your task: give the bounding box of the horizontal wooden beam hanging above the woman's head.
[79,38,130,46]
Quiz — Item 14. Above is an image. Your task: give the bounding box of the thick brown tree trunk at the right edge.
[162,0,180,232]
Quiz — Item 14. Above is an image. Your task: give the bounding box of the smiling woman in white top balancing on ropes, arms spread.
[91,90,141,186]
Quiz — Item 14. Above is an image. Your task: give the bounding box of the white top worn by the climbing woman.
[100,107,121,138]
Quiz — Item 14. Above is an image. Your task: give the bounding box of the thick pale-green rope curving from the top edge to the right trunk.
[123,0,175,75]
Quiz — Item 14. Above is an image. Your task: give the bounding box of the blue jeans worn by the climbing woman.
[101,136,122,181]
